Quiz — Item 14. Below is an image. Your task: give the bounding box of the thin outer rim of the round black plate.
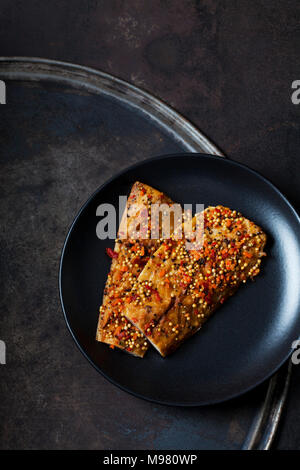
[58,152,300,407]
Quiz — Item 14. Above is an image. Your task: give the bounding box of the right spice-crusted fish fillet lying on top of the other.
[125,206,266,356]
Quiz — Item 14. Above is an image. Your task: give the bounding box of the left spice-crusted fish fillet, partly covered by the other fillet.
[96,181,172,357]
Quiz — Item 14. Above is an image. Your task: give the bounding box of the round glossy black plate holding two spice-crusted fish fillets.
[59,153,300,406]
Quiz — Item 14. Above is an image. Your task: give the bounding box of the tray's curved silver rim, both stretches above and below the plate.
[0,57,291,450]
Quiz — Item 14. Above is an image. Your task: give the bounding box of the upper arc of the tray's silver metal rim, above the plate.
[0,57,224,156]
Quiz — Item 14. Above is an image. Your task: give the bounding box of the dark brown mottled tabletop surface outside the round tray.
[0,0,300,449]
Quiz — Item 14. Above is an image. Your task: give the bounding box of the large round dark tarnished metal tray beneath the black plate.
[0,57,287,449]
